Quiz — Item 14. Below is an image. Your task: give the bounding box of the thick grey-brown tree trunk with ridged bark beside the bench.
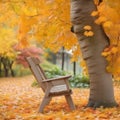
[71,0,117,108]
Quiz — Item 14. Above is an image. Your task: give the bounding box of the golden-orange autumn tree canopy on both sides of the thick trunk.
[0,0,120,78]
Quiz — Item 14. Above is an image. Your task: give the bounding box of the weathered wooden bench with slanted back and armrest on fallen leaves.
[26,57,75,113]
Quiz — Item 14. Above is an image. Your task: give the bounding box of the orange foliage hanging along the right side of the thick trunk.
[92,0,120,79]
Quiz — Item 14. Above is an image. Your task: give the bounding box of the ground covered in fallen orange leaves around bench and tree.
[0,76,120,120]
